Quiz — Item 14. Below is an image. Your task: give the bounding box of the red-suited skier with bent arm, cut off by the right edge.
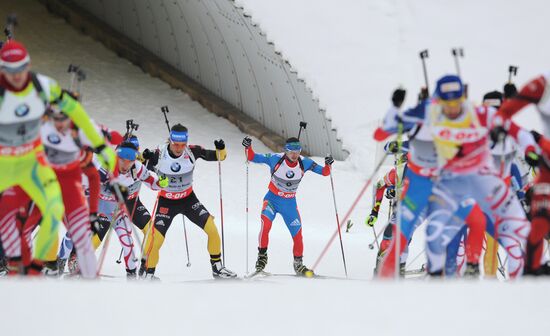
[496,72,550,275]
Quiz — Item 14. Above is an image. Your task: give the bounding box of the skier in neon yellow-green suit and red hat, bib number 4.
[0,40,116,271]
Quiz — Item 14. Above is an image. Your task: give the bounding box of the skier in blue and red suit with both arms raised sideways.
[243,137,334,276]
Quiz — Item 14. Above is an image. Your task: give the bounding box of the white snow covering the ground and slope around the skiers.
[0,0,549,335]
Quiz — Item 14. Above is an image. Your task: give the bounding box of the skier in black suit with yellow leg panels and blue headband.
[139,124,237,278]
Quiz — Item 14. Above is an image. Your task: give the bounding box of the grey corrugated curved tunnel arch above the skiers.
[42,0,347,159]
